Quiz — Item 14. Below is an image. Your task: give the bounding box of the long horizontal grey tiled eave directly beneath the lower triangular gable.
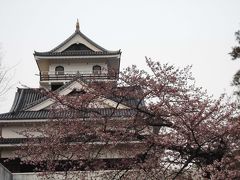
[0,108,136,121]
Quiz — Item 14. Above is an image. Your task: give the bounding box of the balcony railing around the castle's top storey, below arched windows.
[40,71,118,81]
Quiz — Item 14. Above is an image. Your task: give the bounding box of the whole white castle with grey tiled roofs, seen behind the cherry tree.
[0,22,142,176]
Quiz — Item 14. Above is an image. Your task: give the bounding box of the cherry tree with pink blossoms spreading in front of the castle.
[18,58,240,179]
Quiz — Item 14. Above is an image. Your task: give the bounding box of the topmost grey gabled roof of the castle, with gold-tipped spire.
[34,22,121,56]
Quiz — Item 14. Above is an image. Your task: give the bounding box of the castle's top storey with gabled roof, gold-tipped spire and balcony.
[34,21,121,90]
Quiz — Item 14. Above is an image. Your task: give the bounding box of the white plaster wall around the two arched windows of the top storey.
[49,62,107,74]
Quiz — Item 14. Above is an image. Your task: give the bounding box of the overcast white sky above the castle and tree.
[0,0,240,112]
